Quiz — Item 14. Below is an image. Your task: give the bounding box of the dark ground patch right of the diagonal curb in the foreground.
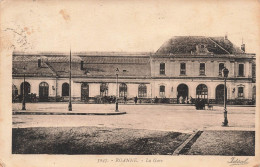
[179,130,255,156]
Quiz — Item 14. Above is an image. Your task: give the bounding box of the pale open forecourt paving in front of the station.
[13,103,255,133]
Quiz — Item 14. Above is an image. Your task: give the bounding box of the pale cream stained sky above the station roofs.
[1,0,260,53]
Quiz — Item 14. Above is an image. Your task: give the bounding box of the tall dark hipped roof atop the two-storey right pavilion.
[156,36,243,55]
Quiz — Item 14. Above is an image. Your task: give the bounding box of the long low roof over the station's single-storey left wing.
[13,54,151,78]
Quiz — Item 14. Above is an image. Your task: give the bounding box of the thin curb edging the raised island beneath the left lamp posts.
[13,112,126,115]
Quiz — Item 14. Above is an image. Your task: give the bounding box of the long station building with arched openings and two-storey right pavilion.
[12,36,256,104]
